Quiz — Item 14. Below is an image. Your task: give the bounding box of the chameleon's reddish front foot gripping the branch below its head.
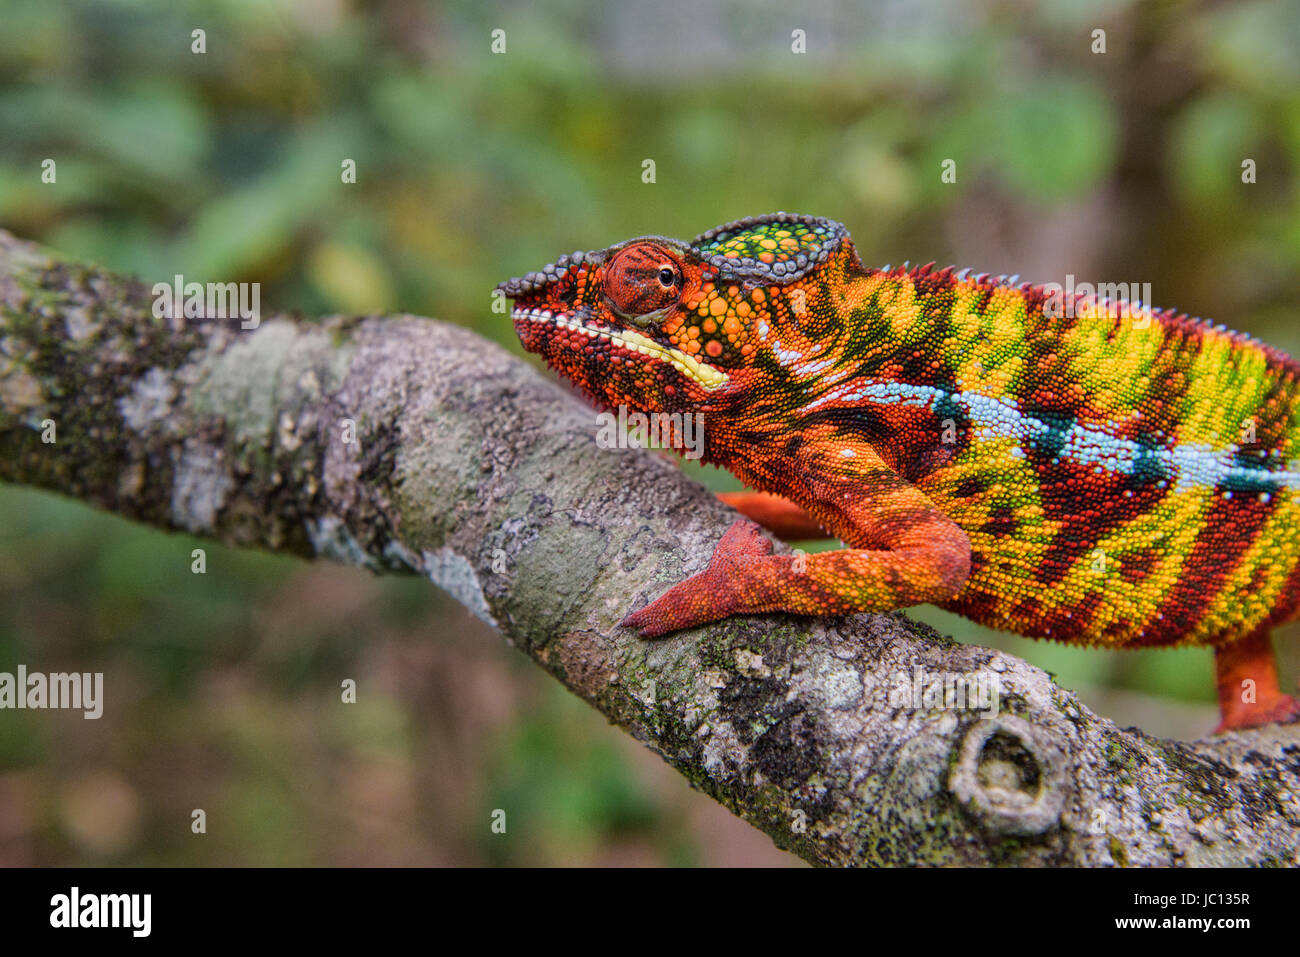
[621,519,792,638]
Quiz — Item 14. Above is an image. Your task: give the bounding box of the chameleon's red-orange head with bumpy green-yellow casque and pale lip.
[498,213,857,412]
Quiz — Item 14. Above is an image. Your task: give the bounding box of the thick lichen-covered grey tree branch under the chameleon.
[0,233,1300,865]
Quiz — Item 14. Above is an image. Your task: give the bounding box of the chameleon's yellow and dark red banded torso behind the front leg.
[847,269,1300,646]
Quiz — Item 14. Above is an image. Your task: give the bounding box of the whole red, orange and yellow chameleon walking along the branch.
[499,213,1300,731]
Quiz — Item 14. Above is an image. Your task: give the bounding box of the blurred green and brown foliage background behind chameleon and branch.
[0,0,1300,865]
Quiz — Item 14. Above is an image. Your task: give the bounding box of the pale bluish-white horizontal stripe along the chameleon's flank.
[809,381,1300,494]
